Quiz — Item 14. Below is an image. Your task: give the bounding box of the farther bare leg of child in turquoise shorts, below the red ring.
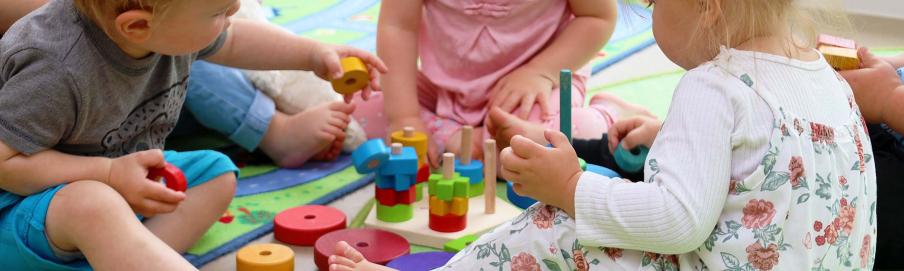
[144,172,236,254]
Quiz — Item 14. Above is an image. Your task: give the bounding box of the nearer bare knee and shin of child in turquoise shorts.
[45,181,195,271]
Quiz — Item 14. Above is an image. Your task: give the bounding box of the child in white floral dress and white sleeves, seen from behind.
[330,0,876,270]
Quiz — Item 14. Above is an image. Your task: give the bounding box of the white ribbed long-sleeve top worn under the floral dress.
[574,49,850,254]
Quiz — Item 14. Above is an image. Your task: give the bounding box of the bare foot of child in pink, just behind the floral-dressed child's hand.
[487,107,549,150]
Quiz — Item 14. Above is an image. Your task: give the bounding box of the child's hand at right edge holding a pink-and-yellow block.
[840,48,901,123]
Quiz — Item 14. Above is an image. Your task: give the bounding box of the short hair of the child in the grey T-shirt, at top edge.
[74,0,174,26]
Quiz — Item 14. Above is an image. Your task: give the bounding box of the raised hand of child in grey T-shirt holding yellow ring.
[311,44,389,102]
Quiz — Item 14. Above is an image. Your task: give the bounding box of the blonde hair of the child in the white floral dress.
[688,0,851,57]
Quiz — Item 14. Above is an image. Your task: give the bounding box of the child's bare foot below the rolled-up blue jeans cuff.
[260,102,355,168]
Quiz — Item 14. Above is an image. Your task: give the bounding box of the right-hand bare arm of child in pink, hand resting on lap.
[491,0,618,119]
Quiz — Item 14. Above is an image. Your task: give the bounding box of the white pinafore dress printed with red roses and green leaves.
[440,54,876,270]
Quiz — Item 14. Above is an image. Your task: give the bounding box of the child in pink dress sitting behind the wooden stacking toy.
[354,0,644,166]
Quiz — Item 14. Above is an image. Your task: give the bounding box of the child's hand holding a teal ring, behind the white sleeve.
[609,116,662,153]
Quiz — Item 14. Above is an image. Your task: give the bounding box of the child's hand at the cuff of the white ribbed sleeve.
[499,130,581,217]
